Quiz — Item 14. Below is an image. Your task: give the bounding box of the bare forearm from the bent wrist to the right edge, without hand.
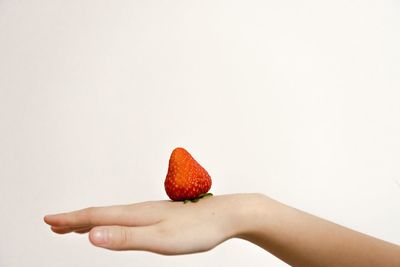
[237,195,400,267]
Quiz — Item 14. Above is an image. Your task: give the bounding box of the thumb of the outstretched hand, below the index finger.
[89,226,159,251]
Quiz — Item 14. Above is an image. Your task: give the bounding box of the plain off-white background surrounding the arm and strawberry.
[0,0,400,267]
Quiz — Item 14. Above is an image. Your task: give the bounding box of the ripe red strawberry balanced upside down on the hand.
[164,147,211,200]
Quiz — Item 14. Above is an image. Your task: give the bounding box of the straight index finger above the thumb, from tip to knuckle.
[44,201,165,227]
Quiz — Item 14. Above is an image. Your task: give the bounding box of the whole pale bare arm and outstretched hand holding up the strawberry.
[44,194,400,267]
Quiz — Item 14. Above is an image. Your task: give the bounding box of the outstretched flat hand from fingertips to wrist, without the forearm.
[44,194,252,255]
